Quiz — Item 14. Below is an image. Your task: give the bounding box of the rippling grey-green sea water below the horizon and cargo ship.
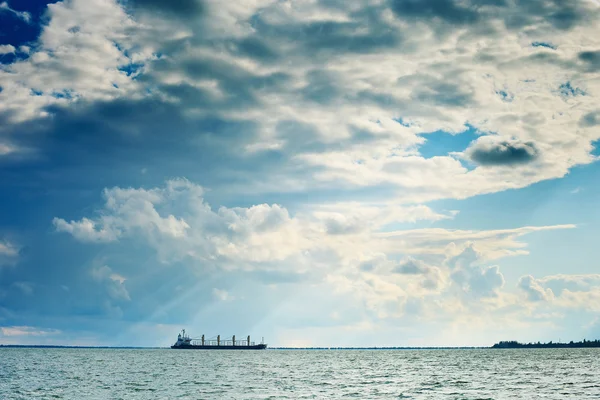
[0,348,600,400]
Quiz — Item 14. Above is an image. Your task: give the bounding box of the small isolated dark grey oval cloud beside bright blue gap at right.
[466,137,539,166]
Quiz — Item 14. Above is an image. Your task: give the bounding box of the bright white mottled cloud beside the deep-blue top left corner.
[0,0,151,121]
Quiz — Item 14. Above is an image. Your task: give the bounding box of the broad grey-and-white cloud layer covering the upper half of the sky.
[0,0,598,209]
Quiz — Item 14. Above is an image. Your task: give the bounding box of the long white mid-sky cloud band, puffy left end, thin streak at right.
[54,179,573,272]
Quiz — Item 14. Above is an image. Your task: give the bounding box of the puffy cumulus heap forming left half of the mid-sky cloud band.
[53,179,308,268]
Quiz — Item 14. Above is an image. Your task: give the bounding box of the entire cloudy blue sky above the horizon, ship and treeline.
[0,0,600,346]
